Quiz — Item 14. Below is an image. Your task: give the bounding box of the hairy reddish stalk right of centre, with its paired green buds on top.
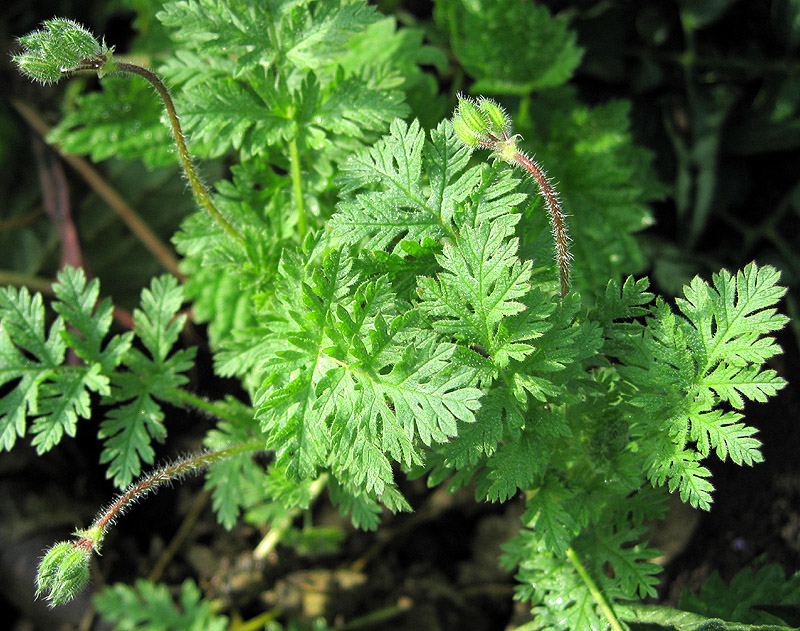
[453,95,572,298]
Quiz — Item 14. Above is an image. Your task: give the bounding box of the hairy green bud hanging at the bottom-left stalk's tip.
[36,541,92,606]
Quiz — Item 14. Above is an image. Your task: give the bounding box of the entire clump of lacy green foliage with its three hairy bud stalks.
[6,0,786,629]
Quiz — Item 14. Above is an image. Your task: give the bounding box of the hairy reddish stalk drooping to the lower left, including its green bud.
[36,441,263,606]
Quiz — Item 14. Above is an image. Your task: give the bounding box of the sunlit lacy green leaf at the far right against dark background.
[599,264,786,509]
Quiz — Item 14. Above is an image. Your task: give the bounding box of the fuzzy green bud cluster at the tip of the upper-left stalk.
[14,18,108,83]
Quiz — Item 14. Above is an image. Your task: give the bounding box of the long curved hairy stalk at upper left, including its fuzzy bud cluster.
[14,18,244,243]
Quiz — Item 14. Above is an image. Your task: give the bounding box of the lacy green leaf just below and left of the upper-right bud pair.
[330,120,526,253]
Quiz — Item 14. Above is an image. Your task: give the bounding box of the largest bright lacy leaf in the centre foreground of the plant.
[258,247,481,495]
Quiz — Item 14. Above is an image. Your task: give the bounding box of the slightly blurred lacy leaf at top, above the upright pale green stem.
[159,0,407,160]
